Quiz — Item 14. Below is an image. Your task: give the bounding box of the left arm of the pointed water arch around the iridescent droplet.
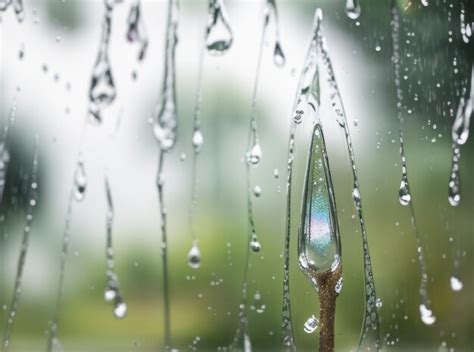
[281,9,322,352]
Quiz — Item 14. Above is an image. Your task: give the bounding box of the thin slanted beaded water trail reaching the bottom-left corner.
[2,136,39,350]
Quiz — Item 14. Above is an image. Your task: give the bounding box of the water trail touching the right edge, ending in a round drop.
[448,64,474,207]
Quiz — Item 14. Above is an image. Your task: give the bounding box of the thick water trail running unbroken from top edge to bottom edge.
[153,0,179,350]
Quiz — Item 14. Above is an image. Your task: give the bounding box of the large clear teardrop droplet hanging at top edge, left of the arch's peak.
[206,0,233,55]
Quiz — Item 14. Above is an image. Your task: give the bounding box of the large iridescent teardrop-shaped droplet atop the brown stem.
[298,123,341,275]
